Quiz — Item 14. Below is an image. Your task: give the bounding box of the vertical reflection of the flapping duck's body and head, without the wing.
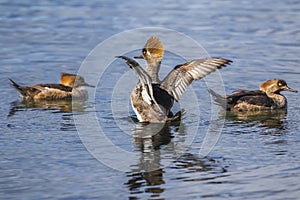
[126,122,179,197]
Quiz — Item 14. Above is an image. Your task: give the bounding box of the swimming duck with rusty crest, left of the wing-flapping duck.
[9,73,94,101]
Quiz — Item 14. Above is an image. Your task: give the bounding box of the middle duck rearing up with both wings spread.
[118,37,232,122]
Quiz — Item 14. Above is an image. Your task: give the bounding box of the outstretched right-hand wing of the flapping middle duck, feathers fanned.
[160,58,232,101]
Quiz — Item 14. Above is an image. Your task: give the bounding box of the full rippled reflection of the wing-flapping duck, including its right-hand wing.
[125,122,227,199]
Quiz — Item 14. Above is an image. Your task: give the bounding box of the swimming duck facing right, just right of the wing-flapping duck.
[208,79,297,112]
